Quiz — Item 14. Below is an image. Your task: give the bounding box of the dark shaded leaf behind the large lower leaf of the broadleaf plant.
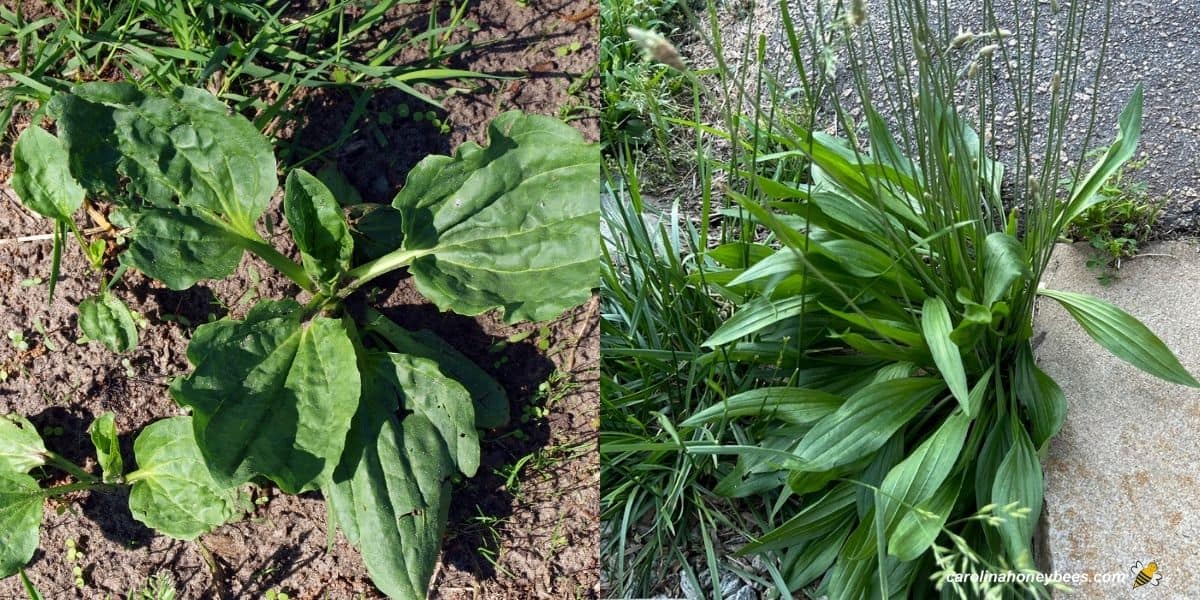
[364,308,509,430]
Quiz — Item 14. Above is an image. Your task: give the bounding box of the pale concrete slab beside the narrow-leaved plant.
[1036,242,1200,599]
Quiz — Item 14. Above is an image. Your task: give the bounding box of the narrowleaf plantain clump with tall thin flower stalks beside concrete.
[672,0,1200,599]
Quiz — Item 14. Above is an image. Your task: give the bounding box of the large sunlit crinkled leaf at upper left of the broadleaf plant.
[71,83,278,232]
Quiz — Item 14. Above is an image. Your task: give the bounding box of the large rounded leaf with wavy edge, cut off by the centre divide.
[392,112,601,323]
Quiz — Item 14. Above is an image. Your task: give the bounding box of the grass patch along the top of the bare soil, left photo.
[0,0,480,151]
